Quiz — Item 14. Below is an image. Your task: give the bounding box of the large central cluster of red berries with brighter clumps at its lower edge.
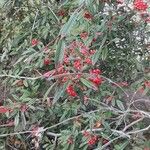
[63,40,102,97]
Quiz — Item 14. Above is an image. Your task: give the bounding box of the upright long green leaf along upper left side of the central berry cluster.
[55,39,65,65]
